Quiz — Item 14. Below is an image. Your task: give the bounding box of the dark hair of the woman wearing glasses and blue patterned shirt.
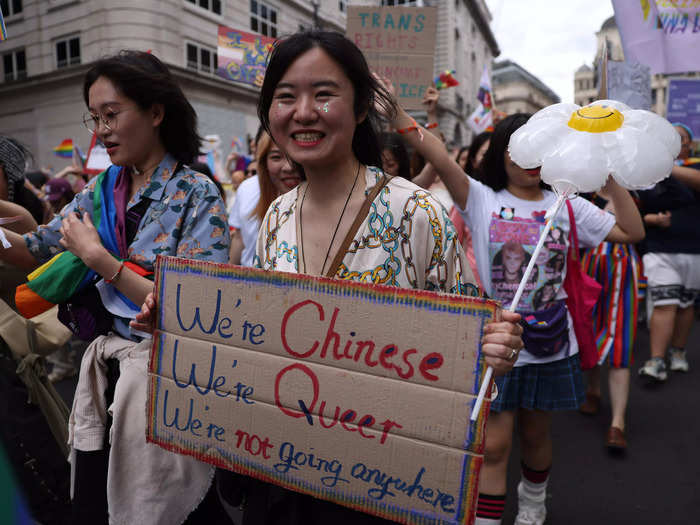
[83,50,202,164]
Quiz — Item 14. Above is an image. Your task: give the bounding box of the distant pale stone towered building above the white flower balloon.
[574,16,700,117]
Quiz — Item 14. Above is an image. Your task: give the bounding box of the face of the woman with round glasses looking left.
[88,77,163,168]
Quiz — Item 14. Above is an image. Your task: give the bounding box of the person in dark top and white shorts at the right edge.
[639,122,700,382]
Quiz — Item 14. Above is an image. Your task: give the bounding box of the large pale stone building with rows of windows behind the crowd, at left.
[0,0,498,169]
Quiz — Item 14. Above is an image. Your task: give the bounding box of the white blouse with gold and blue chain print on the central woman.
[255,167,481,295]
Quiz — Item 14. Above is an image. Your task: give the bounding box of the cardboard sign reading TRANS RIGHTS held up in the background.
[346,6,437,109]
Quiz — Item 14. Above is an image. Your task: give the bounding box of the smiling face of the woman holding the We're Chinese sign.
[269,47,358,168]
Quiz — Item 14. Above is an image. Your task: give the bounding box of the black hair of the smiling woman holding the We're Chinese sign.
[258,31,397,173]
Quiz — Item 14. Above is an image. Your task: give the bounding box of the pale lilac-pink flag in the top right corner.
[612,0,700,73]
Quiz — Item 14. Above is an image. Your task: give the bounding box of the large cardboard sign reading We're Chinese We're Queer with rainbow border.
[147,257,498,524]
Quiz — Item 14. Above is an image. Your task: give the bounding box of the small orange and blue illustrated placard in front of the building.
[216,26,275,87]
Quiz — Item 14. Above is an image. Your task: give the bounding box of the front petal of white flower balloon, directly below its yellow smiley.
[540,130,609,193]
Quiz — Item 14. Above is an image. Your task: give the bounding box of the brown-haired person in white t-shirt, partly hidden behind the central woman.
[228,133,302,266]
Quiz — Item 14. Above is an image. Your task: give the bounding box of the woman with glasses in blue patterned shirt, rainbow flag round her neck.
[0,51,229,524]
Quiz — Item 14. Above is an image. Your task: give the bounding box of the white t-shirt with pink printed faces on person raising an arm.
[459,177,615,366]
